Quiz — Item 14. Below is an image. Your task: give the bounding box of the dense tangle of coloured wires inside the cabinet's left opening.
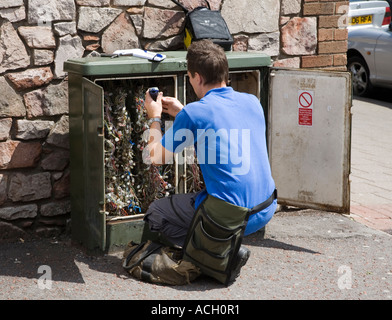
[104,83,175,216]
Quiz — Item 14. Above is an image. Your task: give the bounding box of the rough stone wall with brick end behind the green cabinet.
[0,0,348,239]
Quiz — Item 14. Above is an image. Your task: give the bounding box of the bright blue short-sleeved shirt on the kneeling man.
[161,87,277,235]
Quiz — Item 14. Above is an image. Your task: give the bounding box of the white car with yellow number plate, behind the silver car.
[348,0,391,30]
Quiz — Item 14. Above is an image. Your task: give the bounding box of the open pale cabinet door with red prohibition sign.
[268,69,352,213]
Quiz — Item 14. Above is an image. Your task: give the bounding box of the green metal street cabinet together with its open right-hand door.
[64,51,352,251]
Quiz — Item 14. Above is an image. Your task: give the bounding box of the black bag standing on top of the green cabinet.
[172,0,233,51]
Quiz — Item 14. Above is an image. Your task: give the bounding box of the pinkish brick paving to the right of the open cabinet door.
[351,98,392,234]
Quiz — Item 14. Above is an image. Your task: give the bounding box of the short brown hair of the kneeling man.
[186,40,229,84]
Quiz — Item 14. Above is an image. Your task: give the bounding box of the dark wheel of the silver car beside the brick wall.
[347,56,373,97]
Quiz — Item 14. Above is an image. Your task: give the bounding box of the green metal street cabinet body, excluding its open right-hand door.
[64,51,271,251]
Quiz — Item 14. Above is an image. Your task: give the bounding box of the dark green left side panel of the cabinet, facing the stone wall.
[69,75,106,251]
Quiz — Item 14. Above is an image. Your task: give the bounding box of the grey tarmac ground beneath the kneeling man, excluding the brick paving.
[0,210,392,300]
